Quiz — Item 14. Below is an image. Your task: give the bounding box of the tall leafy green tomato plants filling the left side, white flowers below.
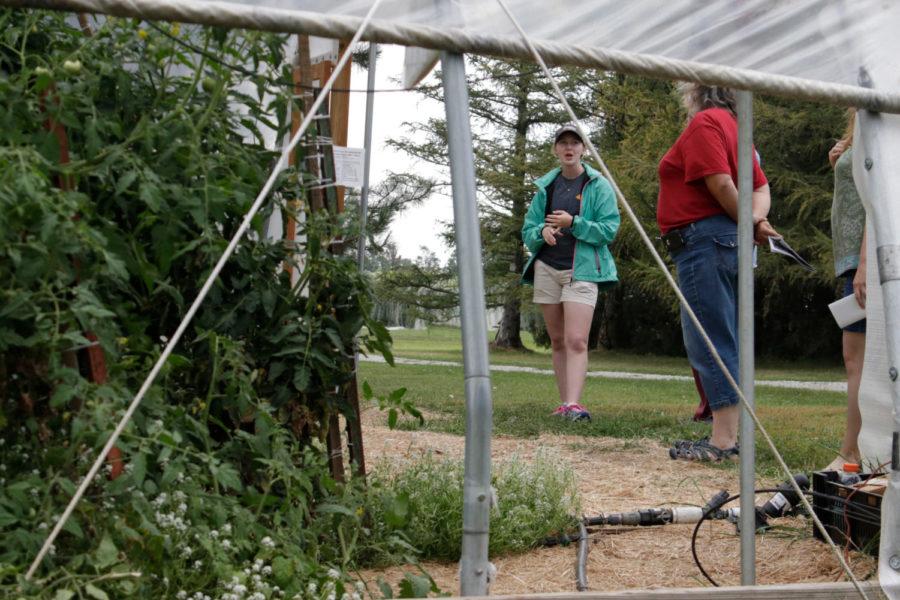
[0,10,414,599]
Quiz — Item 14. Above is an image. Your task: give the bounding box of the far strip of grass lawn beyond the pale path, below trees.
[391,327,845,381]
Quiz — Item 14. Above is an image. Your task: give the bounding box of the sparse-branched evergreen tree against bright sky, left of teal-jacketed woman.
[392,57,591,348]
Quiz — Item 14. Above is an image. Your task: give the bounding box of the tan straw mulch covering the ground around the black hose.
[356,411,877,595]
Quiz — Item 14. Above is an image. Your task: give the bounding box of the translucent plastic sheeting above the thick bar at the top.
[209,0,900,90]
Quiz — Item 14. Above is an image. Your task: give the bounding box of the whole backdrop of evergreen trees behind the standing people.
[377,64,845,361]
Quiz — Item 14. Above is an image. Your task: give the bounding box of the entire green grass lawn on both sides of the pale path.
[359,328,846,476]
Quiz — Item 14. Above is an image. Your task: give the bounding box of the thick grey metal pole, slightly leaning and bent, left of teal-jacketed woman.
[441,52,492,596]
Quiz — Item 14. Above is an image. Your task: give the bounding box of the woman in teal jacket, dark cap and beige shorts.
[522,125,620,420]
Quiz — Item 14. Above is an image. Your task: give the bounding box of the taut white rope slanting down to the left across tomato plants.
[25,0,383,580]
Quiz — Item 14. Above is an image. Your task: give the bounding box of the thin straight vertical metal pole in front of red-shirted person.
[737,86,756,585]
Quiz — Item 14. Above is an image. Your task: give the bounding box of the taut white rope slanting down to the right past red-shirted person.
[497,0,868,600]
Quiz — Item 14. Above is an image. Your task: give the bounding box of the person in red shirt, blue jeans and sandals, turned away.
[656,83,778,461]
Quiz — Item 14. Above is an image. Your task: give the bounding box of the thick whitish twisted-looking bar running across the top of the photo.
[7,0,900,113]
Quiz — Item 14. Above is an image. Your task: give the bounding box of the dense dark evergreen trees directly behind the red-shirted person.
[596,75,844,357]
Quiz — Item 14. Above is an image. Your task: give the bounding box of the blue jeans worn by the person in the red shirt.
[672,215,738,410]
